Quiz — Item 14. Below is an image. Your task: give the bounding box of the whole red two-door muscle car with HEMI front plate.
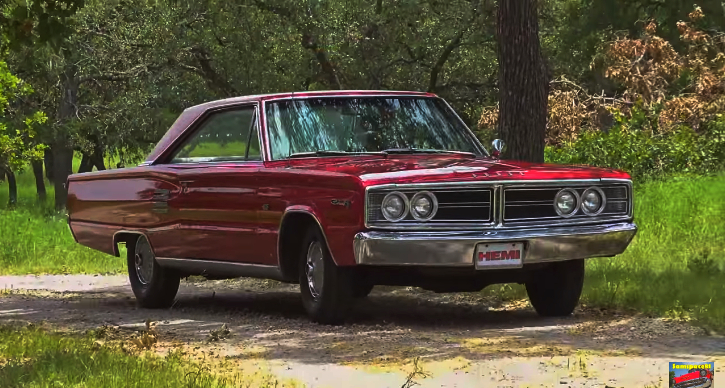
[68,91,637,324]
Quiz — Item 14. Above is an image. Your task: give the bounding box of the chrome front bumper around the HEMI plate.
[354,223,637,267]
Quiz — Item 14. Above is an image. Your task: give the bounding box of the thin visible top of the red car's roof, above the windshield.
[186,90,438,110]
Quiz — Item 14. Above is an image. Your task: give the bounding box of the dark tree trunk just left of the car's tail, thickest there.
[51,66,78,210]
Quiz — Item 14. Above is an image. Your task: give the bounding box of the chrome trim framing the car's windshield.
[261,92,491,162]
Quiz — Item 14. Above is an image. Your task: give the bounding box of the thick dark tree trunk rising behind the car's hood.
[498,0,549,163]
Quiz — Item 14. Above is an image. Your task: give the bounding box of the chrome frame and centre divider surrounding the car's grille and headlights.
[364,178,634,231]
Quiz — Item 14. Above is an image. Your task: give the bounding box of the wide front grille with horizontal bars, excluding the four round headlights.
[365,180,632,230]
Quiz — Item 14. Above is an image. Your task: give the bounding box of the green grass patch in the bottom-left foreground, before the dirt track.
[0,327,296,388]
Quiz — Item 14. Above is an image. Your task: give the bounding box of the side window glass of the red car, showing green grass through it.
[171,107,262,163]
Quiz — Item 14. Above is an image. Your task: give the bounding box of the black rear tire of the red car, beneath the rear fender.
[126,235,181,309]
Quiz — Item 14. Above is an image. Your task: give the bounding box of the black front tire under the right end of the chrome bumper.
[526,259,584,317]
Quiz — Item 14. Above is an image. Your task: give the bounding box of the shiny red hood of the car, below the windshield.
[282,155,629,185]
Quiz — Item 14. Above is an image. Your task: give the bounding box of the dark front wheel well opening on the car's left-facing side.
[278,212,319,282]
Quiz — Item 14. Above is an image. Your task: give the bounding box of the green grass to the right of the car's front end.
[484,175,725,333]
